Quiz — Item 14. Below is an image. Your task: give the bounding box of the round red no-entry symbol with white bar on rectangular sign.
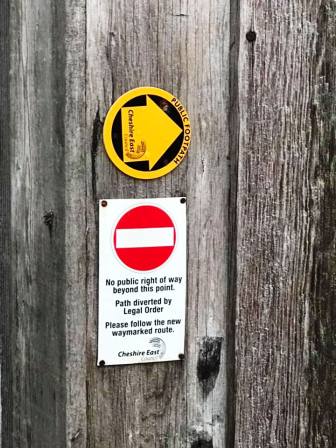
[113,205,176,271]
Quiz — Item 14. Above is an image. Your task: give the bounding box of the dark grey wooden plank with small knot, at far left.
[7,0,66,448]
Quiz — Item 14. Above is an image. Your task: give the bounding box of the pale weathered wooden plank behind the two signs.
[83,0,229,448]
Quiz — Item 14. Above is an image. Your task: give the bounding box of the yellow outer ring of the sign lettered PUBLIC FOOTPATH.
[103,87,191,179]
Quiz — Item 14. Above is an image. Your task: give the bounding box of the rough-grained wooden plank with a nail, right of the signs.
[235,1,336,448]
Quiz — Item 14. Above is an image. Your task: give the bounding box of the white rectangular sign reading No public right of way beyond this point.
[97,198,186,366]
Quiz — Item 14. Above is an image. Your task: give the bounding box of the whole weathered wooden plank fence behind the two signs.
[0,0,336,448]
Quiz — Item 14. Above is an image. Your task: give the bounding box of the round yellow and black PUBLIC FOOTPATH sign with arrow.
[103,87,191,179]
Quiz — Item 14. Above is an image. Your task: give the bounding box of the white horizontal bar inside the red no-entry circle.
[116,227,174,249]
